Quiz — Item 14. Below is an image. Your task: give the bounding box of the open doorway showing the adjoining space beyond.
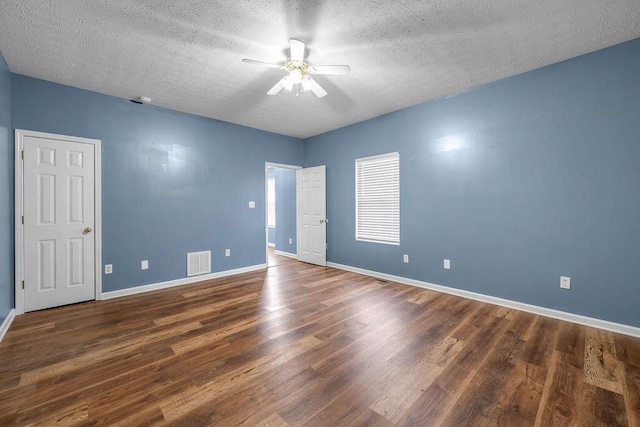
[265,162,301,267]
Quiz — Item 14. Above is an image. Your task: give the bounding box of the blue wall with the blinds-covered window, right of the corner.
[304,39,640,326]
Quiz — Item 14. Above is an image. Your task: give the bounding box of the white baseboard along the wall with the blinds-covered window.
[327,262,640,338]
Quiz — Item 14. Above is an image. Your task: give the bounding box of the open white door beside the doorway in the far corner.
[297,166,327,265]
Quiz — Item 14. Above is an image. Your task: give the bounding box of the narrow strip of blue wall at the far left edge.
[0,53,14,324]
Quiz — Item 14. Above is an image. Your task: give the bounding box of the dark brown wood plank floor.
[0,252,640,426]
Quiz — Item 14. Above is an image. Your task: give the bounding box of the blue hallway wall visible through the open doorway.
[275,168,297,254]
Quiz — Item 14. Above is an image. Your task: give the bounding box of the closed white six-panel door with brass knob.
[23,136,96,311]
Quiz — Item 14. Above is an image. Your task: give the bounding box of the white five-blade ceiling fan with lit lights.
[242,39,351,98]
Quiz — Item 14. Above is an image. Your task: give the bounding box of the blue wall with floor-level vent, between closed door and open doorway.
[11,74,302,292]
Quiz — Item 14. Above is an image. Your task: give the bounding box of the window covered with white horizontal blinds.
[356,153,400,245]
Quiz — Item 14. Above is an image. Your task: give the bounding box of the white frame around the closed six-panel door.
[14,129,102,314]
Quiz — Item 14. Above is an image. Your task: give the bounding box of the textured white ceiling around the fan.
[0,0,640,138]
